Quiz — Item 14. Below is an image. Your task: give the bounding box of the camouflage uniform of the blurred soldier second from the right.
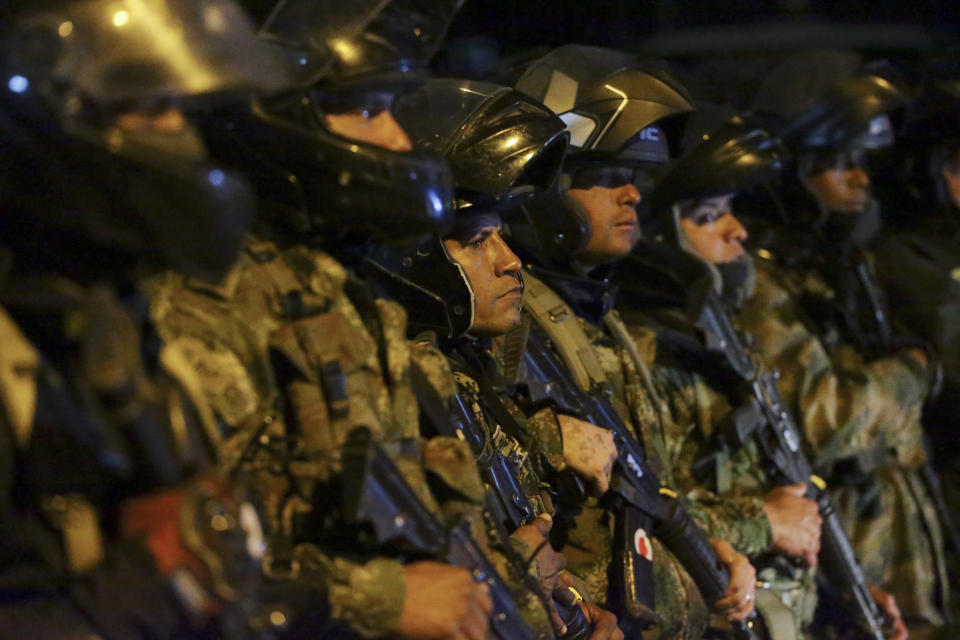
[739,251,947,624]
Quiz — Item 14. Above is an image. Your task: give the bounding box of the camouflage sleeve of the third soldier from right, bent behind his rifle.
[652,364,773,557]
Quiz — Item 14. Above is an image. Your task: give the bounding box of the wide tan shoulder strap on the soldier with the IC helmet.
[523,271,607,391]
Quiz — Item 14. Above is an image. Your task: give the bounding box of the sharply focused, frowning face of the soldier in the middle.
[443,216,523,338]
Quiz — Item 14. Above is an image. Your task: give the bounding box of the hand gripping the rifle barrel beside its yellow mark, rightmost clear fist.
[763,482,823,567]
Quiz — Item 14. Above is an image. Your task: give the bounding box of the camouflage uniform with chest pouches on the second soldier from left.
[149,239,552,635]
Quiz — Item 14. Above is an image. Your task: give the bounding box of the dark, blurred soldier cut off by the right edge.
[873,76,960,553]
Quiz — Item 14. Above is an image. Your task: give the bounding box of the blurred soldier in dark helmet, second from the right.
[740,53,948,625]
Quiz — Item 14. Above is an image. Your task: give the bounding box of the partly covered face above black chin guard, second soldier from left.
[323,94,413,151]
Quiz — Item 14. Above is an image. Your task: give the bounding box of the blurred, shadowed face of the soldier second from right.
[803,151,870,215]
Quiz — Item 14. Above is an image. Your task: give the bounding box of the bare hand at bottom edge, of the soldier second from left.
[399,562,493,640]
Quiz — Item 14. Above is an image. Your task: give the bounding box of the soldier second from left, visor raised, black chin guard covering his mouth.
[145,2,550,639]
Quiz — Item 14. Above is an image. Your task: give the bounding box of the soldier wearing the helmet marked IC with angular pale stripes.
[510,46,754,638]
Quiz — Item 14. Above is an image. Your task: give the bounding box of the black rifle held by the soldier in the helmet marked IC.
[520,327,760,640]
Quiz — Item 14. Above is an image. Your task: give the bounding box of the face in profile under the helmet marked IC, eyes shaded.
[567,169,640,266]
